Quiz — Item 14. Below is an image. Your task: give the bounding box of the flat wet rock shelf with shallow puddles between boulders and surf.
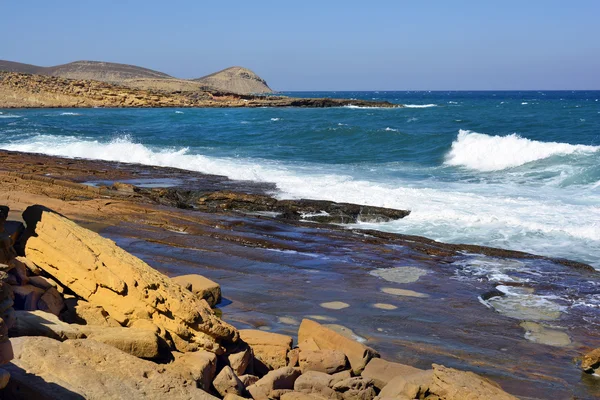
[0,152,600,399]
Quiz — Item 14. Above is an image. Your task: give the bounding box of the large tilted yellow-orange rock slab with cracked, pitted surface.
[23,206,238,353]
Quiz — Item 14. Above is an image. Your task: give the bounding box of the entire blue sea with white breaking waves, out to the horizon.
[0,91,600,269]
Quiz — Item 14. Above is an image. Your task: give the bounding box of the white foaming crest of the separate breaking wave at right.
[445,129,600,171]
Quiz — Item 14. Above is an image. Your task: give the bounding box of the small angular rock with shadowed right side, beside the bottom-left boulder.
[167,350,217,392]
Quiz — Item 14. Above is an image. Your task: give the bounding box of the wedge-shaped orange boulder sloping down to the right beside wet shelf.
[298,319,379,375]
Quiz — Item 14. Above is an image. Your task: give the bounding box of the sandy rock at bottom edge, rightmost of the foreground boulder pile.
[429,364,517,400]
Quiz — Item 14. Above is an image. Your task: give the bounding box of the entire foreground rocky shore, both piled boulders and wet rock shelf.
[0,152,600,400]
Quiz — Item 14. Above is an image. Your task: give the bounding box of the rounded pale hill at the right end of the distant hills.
[193,67,273,93]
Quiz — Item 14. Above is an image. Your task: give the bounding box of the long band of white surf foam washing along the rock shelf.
[0,132,600,268]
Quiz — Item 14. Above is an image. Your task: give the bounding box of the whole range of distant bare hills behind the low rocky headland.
[0,60,273,95]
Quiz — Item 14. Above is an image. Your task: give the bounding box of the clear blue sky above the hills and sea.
[0,0,600,90]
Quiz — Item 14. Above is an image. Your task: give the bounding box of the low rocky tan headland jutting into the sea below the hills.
[0,71,401,108]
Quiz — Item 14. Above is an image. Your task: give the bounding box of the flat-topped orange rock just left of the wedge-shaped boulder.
[240,329,293,369]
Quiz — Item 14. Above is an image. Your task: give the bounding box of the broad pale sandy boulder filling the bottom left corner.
[4,337,215,400]
